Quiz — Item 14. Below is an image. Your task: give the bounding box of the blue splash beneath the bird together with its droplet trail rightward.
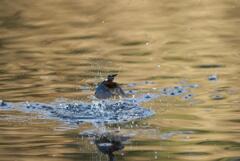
[0,82,195,124]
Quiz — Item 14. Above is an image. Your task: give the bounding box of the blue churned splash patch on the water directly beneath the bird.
[0,100,154,124]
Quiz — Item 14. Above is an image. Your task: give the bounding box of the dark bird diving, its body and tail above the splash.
[95,74,126,99]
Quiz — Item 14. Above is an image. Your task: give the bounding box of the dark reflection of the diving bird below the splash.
[95,133,129,161]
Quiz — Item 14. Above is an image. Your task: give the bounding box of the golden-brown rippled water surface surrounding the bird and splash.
[0,0,240,161]
